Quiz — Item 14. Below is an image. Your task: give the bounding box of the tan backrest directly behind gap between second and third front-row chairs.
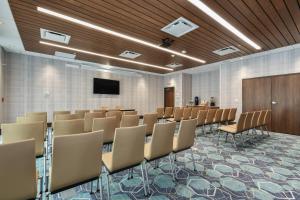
[93,117,118,143]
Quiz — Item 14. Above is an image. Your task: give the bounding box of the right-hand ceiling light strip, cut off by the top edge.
[188,0,261,50]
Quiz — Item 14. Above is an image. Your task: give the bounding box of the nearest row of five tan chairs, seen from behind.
[0,116,197,199]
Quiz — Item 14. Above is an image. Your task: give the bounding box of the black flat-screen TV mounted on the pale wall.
[94,78,120,94]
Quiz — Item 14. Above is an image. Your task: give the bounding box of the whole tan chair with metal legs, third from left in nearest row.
[102,125,147,199]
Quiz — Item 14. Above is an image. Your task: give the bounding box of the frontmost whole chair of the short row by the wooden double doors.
[218,113,248,149]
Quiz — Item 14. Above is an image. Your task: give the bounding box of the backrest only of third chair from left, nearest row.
[111,125,146,171]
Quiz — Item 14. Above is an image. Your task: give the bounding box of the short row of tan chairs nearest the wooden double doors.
[218,110,271,148]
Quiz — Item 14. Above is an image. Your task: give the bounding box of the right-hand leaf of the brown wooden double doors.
[272,74,300,135]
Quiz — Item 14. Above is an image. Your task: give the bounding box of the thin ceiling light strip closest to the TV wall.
[40,41,173,71]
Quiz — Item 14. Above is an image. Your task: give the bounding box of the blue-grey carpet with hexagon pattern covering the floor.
[37,130,300,200]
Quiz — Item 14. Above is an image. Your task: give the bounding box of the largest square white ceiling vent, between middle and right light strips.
[161,17,199,37]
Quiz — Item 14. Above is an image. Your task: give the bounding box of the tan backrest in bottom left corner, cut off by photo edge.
[0,139,37,199]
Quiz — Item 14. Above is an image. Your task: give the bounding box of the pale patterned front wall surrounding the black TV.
[4,53,164,122]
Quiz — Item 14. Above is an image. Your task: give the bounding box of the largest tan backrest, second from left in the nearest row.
[49,131,103,192]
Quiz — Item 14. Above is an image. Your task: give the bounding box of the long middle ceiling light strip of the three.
[37,7,206,63]
